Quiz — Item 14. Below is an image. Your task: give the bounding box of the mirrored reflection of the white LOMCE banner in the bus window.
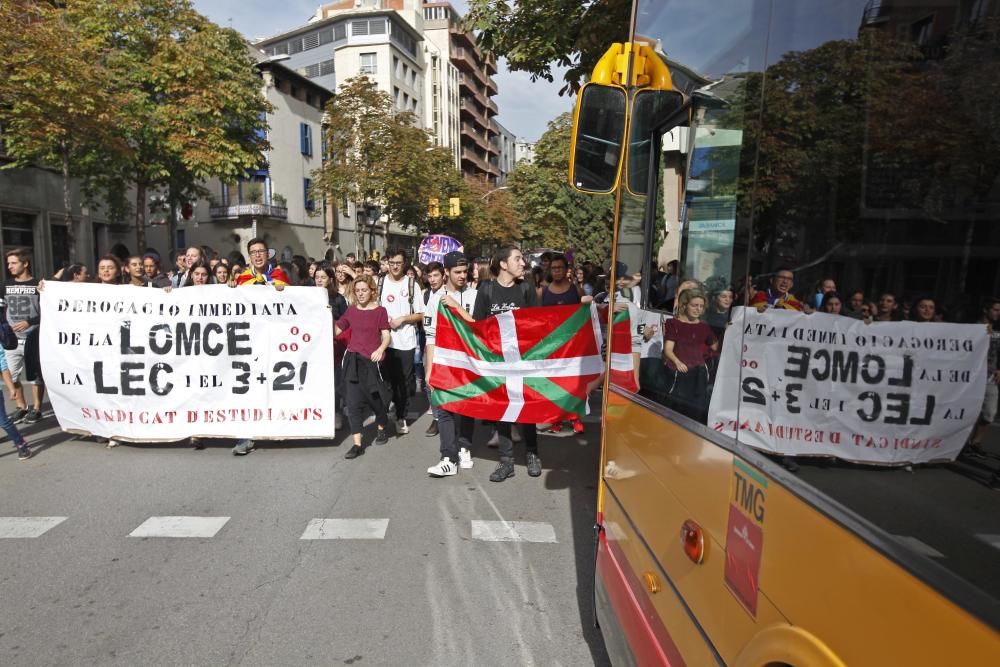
[709,308,989,465]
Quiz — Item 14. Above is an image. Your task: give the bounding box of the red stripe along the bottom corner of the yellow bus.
[597,530,686,667]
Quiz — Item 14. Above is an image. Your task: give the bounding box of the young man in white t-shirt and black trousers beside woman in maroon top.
[378,248,424,435]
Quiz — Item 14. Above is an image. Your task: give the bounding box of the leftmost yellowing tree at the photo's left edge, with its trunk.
[0,0,129,263]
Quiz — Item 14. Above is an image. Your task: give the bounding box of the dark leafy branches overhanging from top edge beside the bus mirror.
[466,0,632,94]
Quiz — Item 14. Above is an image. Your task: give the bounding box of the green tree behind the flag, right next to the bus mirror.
[509,113,614,262]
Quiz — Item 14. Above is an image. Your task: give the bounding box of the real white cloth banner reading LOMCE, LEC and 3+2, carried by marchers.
[40,281,334,442]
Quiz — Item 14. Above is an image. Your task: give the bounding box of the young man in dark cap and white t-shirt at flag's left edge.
[424,251,478,477]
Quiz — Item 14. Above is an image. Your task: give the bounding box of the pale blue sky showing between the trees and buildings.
[193,0,573,141]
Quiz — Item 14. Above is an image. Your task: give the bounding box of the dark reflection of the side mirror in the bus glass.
[625,88,688,195]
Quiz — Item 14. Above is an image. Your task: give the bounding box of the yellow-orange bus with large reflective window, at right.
[570,0,1000,667]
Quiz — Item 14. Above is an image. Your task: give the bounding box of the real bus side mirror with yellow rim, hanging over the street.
[569,83,627,194]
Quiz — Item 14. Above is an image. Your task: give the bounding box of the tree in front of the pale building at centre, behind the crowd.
[313,75,462,248]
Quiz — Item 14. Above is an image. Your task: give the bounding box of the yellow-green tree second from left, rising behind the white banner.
[77,0,270,251]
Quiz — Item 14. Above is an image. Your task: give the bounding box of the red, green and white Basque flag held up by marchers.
[430,304,604,424]
